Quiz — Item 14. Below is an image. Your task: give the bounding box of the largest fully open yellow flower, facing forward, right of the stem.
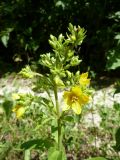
[63,86,89,114]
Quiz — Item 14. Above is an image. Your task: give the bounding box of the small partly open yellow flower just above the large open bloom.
[79,72,90,86]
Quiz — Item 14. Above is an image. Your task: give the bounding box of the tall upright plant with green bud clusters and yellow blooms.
[13,23,90,160]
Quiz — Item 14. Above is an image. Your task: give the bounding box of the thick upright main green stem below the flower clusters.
[54,84,62,150]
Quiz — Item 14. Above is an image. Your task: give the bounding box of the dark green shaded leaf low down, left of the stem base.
[21,138,53,150]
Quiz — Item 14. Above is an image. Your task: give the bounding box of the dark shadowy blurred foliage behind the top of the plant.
[0,0,120,72]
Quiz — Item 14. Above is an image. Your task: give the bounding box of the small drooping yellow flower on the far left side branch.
[12,105,25,118]
